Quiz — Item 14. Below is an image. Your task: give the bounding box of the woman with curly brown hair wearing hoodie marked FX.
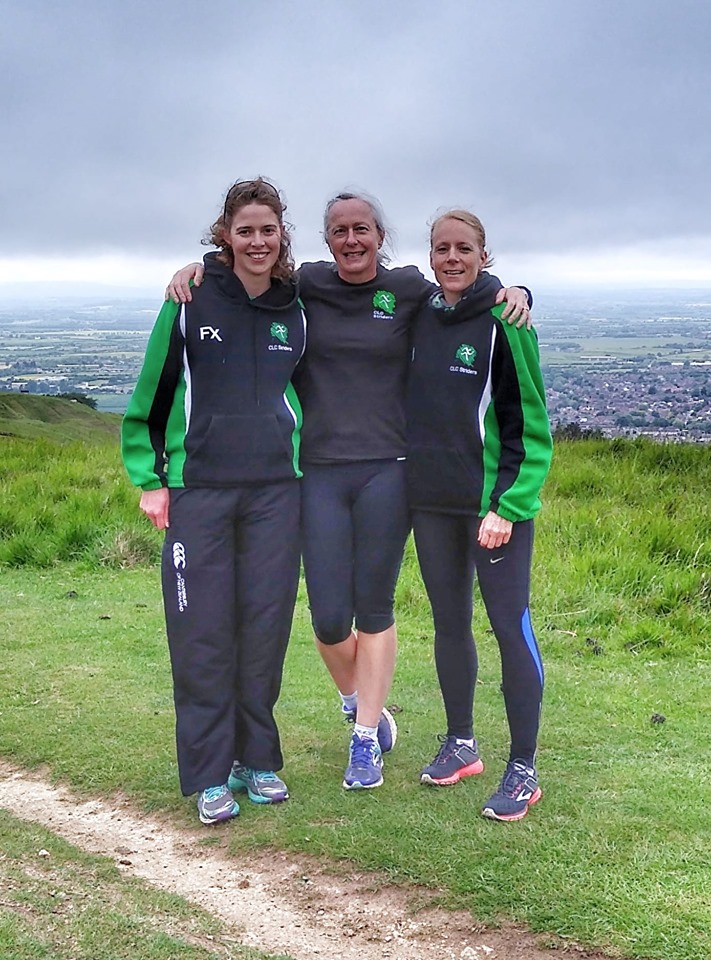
[122,177,306,823]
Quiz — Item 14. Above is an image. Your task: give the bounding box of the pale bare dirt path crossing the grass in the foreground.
[0,762,604,960]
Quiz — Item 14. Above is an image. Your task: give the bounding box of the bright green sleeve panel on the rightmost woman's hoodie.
[492,304,553,522]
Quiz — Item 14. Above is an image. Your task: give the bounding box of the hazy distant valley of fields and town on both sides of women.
[0,290,711,443]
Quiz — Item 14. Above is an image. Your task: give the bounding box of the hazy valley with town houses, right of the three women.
[536,291,711,443]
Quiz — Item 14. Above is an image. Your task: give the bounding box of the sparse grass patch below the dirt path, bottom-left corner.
[0,811,284,960]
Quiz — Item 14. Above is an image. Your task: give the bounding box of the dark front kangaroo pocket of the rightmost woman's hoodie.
[407,446,481,513]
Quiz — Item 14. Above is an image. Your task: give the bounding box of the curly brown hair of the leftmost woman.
[202,177,296,280]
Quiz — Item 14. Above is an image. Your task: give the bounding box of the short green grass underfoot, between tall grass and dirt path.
[0,567,711,960]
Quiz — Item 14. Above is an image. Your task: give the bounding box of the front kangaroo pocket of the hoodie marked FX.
[185,414,295,487]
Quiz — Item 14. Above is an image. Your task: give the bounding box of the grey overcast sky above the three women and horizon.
[0,0,711,292]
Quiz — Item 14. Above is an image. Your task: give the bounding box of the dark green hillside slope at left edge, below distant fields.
[0,393,121,443]
